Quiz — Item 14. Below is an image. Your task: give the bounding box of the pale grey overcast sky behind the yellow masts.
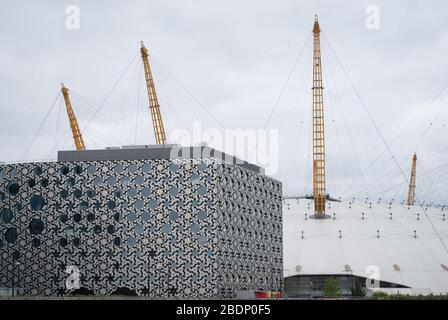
[0,0,448,202]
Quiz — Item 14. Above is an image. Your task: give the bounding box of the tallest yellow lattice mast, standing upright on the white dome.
[312,15,326,218]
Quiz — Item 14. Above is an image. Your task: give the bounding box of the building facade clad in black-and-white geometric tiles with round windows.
[0,149,283,298]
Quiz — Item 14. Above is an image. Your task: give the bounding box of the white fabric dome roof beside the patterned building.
[283,199,448,294]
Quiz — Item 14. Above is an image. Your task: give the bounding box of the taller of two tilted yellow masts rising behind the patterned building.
[140,41,166,144]
